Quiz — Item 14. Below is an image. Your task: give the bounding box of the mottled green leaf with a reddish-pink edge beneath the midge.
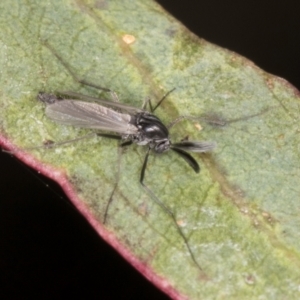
[0,0,300,299]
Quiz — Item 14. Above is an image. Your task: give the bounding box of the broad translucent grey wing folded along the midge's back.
[46,100,137,134]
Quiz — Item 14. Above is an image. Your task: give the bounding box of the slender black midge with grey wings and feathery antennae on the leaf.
[38,86,216,270]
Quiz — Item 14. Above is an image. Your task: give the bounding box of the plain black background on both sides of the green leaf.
[0,0,300,299]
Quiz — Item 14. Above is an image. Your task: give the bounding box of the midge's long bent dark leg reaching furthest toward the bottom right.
[140,148,203,272]
